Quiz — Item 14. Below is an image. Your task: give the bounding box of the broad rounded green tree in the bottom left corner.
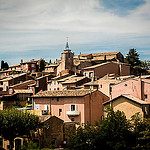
[0,109,39,149]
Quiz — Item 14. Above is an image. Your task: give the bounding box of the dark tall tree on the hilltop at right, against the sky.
[126,48,141,67]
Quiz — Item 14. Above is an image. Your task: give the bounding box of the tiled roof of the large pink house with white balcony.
[33,89,96,97]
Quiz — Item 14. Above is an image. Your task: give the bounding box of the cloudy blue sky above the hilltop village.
[0,0,150,65]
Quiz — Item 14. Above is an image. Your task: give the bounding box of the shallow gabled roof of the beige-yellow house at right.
[103,94,150,105]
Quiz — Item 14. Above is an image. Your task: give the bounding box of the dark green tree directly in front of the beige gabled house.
[99,108,132,150]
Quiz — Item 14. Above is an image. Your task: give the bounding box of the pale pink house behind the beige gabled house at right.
[111,77,150,103]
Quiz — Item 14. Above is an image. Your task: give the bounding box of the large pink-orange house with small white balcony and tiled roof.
[33,90,109,125]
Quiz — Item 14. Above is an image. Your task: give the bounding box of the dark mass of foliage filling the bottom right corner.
[68,108,150,150]
